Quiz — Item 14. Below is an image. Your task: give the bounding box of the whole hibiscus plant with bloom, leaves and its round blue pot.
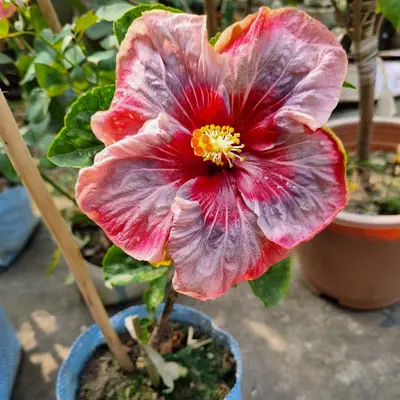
[48,4,347,400]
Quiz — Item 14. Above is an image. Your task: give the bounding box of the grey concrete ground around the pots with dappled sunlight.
[0,226,400,400]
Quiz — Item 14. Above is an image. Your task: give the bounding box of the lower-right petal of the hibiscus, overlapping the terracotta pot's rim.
[235,128,347,248]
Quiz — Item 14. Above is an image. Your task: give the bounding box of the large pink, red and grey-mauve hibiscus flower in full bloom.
[76,7,347,300]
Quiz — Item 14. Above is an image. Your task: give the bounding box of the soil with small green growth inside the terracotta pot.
[346,149,400,215]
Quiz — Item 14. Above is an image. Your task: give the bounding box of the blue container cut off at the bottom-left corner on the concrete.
[0,306,21,400]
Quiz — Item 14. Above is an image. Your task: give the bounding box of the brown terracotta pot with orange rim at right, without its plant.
[297,118,400,309]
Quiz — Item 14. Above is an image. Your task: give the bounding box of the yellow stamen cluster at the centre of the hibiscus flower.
[191,124,244,168]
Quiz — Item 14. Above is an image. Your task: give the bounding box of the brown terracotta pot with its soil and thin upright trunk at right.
[297,0,400,309]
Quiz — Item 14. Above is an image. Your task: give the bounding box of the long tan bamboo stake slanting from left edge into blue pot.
[0,91,133,371]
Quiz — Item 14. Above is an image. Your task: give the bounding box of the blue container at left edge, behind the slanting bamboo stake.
[0,186,39,269]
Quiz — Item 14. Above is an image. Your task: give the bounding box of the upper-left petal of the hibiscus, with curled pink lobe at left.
[92,11,229,145]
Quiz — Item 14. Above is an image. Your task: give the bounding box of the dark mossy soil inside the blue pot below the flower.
[77,322,236,400]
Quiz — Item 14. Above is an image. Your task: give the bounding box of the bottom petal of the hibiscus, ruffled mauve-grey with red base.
[168,173,288,300]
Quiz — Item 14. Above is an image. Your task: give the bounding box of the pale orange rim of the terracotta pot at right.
[328,116,400,229]
